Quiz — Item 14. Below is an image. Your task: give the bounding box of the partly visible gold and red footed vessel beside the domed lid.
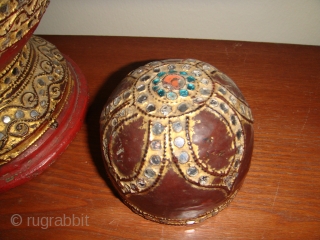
[0,0,88,192]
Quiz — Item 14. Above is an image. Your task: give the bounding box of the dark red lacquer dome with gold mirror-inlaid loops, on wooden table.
[100,59,253,225]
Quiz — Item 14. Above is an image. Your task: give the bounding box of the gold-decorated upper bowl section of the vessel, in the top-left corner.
[0,0,50,56]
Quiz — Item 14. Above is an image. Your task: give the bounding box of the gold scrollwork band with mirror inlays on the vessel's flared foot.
[0,36,73,165]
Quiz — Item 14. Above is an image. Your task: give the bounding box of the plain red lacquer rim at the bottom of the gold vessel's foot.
[0,56,88,192]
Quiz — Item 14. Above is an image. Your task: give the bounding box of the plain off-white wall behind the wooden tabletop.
[36,0,320,45]
